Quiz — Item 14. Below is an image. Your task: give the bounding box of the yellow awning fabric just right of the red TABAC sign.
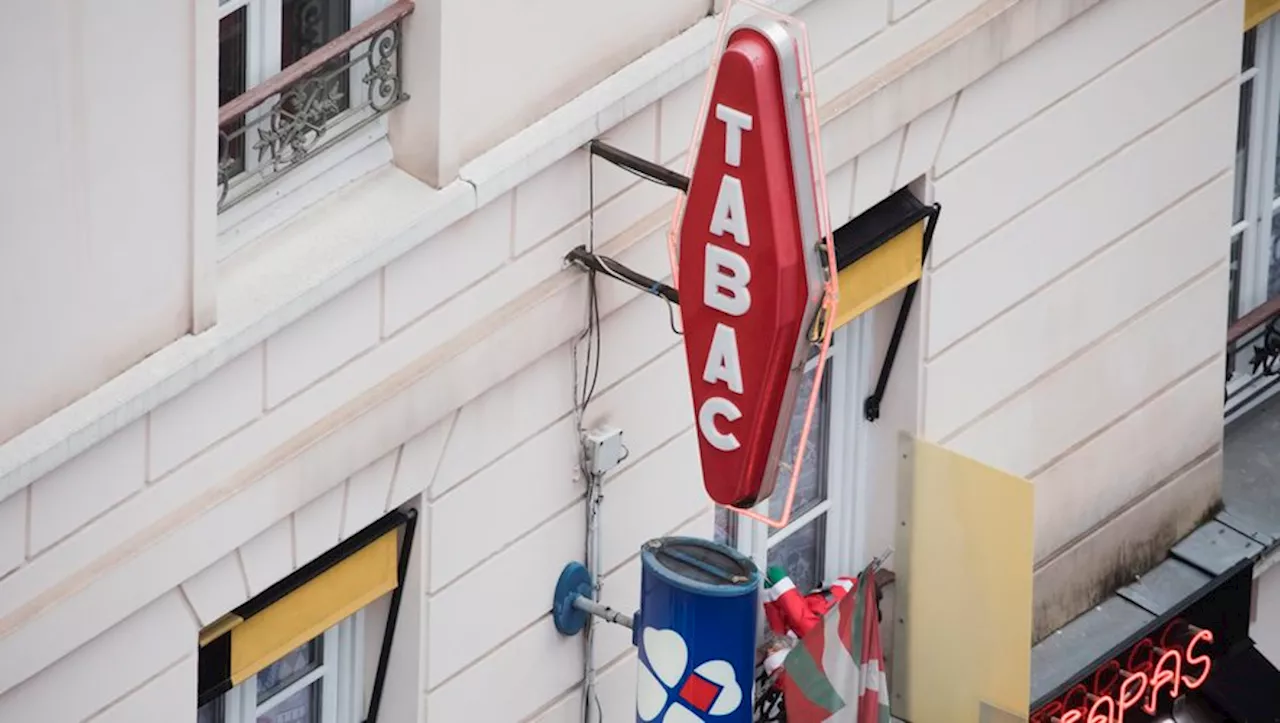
[836,220,928,329]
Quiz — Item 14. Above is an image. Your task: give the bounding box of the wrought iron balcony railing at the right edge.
[1225,291,1280,421]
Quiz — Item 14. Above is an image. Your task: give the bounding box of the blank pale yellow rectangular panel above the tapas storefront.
[890,434,1033,723]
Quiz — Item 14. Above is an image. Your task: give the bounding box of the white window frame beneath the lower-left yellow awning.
[202,609,365,723]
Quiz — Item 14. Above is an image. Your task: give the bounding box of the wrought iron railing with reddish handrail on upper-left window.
[218,0,413,211]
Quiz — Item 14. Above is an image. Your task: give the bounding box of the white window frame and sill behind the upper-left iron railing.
[215,0,393,255]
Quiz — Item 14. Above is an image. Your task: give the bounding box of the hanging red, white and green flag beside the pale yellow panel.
[782,567,890,723]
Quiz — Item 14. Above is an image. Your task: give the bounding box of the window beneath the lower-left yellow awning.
[196,612,365,723]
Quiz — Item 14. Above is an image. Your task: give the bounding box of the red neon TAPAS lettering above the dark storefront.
[1032,626,1213,723]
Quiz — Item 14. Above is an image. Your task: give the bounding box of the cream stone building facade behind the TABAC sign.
[0,0,1280,723]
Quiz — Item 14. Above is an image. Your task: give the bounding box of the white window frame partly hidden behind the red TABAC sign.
[726,314,872,585]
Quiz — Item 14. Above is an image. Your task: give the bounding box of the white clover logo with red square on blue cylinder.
[636,627,742,723]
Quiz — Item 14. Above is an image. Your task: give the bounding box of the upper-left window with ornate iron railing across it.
[206,0,413,217]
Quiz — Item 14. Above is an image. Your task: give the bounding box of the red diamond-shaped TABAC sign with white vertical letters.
[678,20,823,508]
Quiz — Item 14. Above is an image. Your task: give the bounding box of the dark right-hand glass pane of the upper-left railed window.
[280,0,351,119]
